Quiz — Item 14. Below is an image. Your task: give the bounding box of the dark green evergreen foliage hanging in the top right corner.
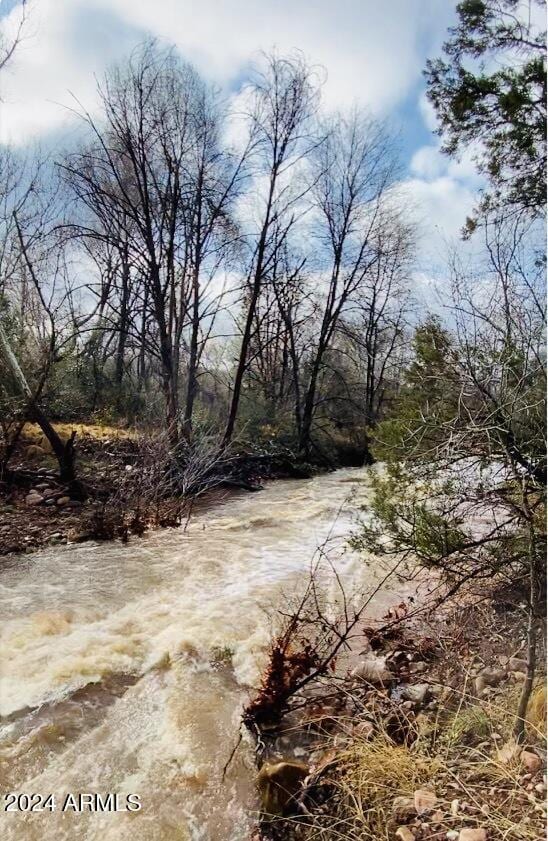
[425,0,546,225]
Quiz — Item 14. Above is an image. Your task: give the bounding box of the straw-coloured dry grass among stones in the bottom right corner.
[298,685,546,841]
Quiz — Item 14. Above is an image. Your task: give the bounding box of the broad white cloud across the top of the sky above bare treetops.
[0,0,447,143]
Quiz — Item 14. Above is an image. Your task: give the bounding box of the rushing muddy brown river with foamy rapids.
[0,470,394,841]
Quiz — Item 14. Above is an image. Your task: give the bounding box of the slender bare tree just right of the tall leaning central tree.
[299,112,396,457]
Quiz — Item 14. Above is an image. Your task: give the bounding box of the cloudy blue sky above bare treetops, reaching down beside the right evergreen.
[0,0,478,277]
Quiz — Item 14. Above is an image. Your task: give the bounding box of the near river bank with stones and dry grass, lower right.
[249,576,546,841]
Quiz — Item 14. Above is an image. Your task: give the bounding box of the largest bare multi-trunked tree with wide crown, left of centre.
[63,43,240,446]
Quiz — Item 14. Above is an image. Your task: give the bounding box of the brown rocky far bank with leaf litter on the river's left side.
[0,424,318,556]
